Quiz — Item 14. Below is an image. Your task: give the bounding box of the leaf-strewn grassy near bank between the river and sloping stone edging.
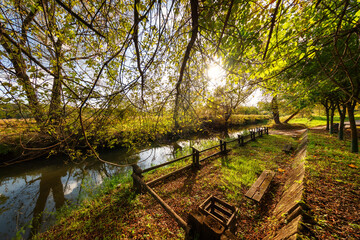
[35,132,295,239]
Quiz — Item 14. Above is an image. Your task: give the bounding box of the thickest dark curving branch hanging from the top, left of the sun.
[173,0,199,129]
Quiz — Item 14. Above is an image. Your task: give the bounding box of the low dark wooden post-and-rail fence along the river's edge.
[131,127,269,233]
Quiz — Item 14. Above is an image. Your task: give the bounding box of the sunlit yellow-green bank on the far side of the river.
[0,115,269,166]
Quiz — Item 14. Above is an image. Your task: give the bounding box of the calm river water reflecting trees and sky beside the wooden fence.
[0,129,253,239]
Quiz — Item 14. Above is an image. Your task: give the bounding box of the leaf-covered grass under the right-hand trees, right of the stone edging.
[305,130,360,239]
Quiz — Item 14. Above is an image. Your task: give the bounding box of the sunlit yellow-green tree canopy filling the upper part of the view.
[0,0,360,158]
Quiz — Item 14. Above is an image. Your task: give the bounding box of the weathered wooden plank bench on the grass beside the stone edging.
[245,170,275,202]
